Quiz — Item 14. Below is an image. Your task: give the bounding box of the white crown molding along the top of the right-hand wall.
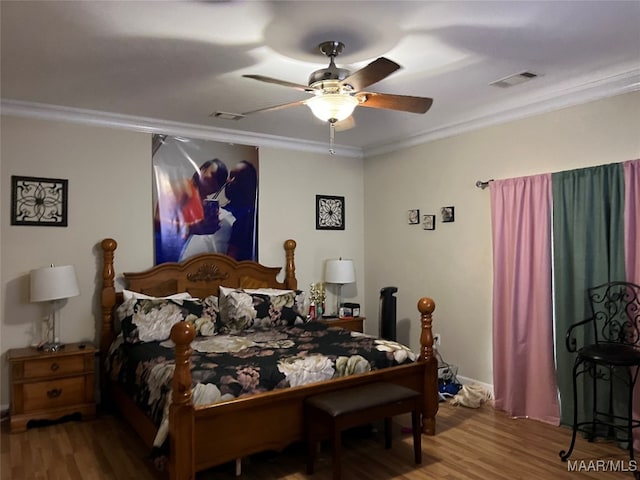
[364,67,640,158]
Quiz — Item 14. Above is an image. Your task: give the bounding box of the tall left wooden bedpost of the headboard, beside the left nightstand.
[99,238,118,400]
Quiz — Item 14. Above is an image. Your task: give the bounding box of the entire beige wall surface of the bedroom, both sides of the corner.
[0,92,640,407]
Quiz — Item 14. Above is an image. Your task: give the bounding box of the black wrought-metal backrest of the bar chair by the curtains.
[587,282,640,347]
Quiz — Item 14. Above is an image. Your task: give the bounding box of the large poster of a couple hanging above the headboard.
[152,135,259,264]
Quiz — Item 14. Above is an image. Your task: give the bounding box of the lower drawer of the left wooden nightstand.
[22,377,85,412]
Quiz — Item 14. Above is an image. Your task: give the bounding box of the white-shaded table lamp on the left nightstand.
[30,265,80,352]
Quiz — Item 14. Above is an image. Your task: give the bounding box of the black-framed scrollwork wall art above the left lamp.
[11,175,69,227]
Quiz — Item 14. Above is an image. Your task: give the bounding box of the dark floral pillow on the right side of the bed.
[217,287,305,333]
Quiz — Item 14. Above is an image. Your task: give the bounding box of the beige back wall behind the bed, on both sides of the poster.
[0,116,364,408]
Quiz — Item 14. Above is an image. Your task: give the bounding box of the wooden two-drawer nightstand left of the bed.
[7,343,96,432]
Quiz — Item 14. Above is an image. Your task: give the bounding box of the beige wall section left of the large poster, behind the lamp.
[0,117,152,406]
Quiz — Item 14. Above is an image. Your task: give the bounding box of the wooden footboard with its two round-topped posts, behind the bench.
[169,298,438,480]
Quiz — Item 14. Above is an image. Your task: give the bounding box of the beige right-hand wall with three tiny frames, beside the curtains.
[365,92,640,384]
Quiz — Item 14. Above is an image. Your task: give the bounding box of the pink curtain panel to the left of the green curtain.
[490,174,560,425]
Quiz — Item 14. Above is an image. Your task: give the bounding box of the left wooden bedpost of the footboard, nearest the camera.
[169,322,196,480]
